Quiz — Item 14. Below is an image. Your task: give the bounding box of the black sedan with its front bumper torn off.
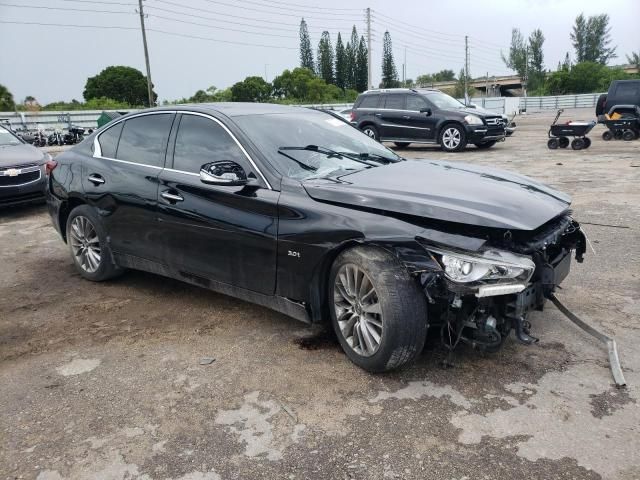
[48,104,585,372]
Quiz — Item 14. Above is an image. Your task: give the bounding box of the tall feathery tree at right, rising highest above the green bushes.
[570,13,617,65]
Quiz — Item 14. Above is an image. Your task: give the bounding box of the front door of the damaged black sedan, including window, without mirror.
[158,113,279,294]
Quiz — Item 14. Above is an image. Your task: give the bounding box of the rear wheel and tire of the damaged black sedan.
[66,205,123,282]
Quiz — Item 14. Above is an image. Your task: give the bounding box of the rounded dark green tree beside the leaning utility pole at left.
[83,65,158,106]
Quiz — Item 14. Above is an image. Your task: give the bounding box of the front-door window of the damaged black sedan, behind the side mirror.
[173,114,248,173]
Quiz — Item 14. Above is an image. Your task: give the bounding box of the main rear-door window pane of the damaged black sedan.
[115,113,173,167]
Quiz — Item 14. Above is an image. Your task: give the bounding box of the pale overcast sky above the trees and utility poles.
[0,0,640,104]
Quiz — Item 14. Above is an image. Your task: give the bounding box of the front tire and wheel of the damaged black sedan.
[328,247,428,373]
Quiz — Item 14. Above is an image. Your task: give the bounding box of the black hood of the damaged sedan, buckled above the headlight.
[303,160,571,230]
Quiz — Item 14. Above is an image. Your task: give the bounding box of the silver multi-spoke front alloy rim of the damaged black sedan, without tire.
[333,264,383,357]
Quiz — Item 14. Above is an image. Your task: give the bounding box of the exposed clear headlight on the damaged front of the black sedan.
[429,248,536,285]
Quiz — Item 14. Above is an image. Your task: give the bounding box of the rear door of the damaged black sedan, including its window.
[82,112,175,261]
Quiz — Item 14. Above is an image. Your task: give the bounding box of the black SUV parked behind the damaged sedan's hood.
[351,88,506,152]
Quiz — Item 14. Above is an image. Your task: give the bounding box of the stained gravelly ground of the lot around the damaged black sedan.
[0,110,640,480]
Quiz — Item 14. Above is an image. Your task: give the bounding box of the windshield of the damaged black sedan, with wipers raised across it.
[233,108,401,180]
